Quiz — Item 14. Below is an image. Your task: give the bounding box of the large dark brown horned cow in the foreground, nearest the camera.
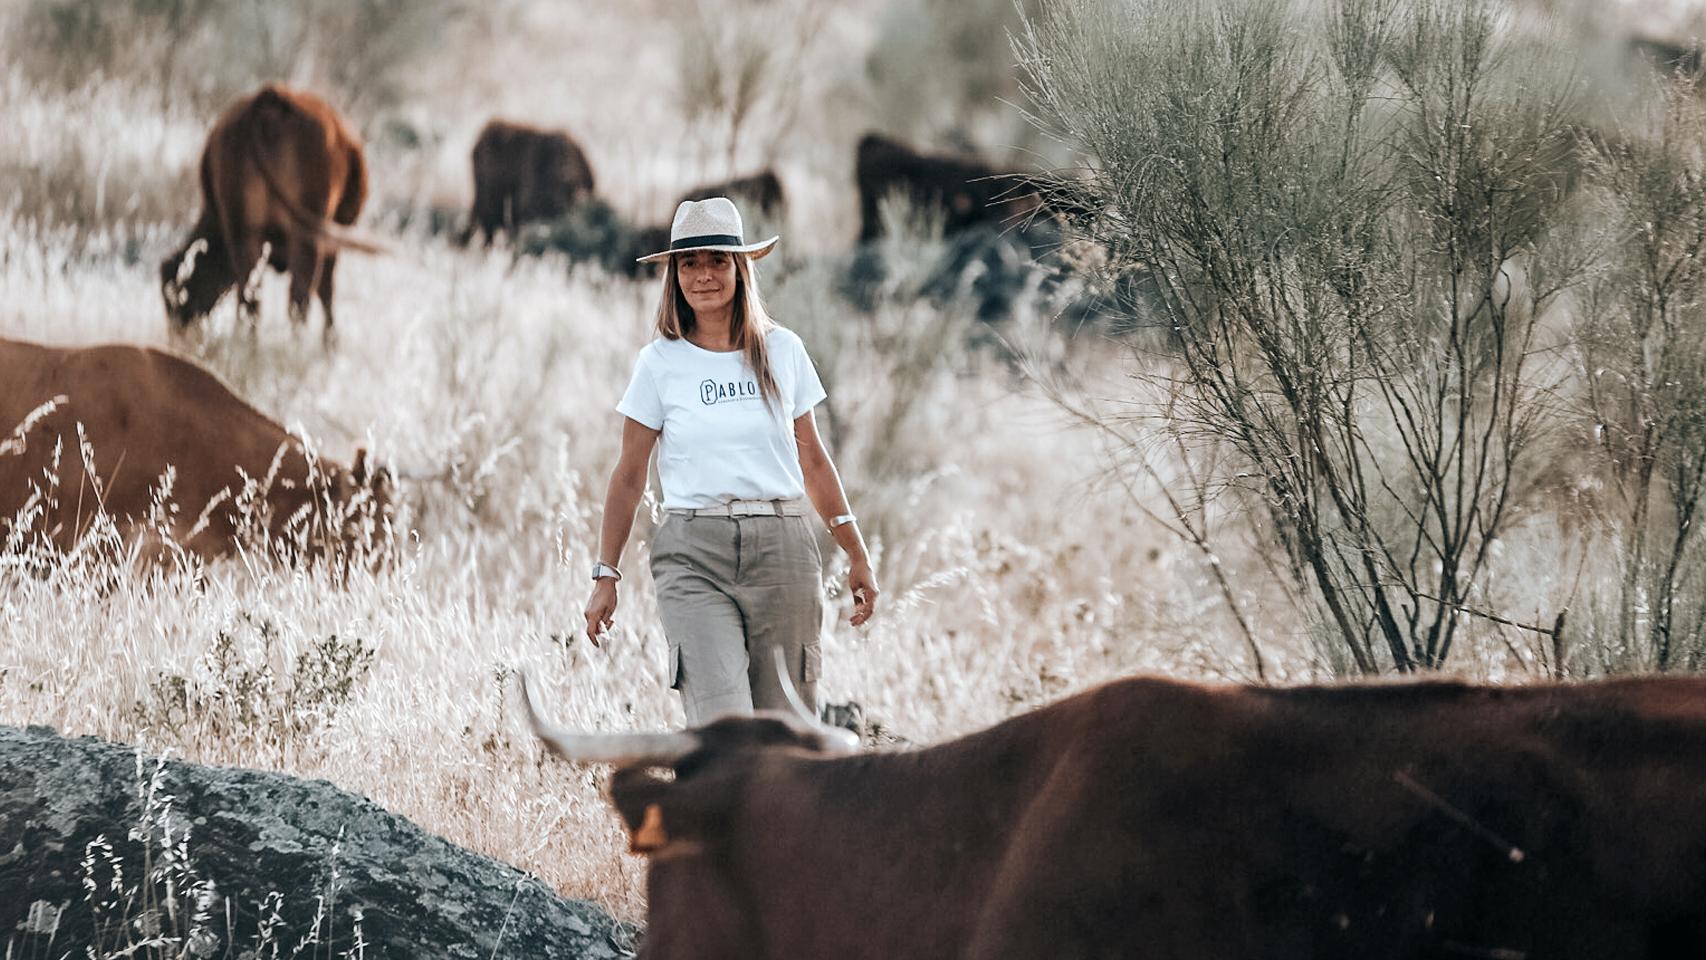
[527,677,1706,960]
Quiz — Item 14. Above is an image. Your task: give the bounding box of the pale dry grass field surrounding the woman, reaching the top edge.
[0,0,1617,917]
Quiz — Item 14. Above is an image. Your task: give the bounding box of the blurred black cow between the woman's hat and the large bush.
[853,133,1041,242]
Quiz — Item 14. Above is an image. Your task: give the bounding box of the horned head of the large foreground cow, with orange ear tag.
[522,672,858,861]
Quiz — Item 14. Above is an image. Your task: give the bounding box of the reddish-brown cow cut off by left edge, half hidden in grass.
[0,339,391,559]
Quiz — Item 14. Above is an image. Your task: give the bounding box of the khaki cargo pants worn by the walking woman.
[652,512,824,726]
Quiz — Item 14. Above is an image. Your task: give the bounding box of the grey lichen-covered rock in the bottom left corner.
[0,726,633,960]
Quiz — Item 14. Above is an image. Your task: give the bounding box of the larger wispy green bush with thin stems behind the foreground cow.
[1020,0,1590,672]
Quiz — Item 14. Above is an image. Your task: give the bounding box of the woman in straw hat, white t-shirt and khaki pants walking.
[587,196,877,726]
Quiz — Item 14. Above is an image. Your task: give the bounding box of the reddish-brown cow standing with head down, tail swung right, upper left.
[160,84,380,344]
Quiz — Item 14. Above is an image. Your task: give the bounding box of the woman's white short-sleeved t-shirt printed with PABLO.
[616,327,827,510]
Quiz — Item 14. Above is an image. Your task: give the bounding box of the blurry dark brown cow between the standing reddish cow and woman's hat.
[462,119,594,244]
